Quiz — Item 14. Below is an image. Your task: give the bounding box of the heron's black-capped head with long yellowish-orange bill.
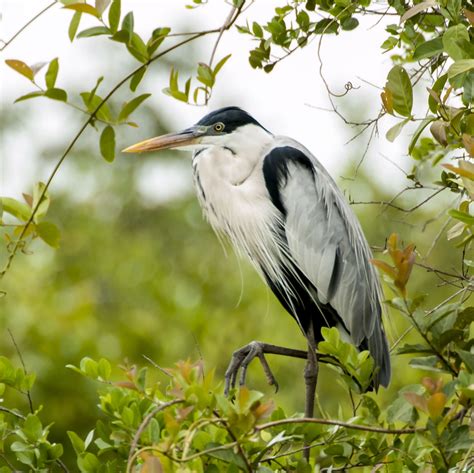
[123,107,269,153]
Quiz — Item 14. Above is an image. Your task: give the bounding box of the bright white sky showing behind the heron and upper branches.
[0,0,409,201]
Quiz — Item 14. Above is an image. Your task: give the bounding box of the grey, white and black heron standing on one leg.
[124,106,391,417]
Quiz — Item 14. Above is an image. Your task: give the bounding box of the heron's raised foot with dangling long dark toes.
[224,341,278,396]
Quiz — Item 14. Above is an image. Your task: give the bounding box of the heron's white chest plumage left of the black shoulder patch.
[193,148,278,257]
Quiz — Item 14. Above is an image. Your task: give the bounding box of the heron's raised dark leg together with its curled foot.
[224,341,308,396]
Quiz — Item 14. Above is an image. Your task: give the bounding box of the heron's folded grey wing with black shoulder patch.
[265,142,390,385]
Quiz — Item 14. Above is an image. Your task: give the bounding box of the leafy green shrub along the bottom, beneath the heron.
[0,299,474,473]
